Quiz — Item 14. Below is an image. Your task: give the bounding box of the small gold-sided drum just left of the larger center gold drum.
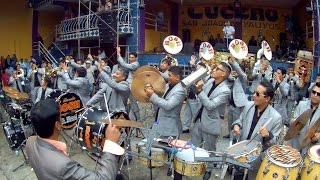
[137,139,168,167]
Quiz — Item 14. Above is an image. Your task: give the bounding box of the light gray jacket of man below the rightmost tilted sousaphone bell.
[249,64,272,93]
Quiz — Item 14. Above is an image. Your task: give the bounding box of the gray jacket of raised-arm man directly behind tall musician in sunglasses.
[230,61,248,107]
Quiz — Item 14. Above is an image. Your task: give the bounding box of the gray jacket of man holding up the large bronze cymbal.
[149,82,187,136]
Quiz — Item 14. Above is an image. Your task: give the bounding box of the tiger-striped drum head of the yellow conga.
[267,145,302,168]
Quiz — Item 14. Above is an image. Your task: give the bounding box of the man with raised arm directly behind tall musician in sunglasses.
[224,56,248,138]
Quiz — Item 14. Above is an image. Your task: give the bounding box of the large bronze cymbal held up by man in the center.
[131,71,166,103]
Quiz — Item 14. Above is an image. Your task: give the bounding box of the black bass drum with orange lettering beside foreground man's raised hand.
[76,107,108,155]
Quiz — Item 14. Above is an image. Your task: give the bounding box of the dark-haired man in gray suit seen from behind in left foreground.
[26,99,124,180]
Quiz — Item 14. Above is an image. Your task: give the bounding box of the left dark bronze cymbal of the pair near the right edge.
[283,109,312,141]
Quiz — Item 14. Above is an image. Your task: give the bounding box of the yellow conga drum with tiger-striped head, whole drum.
[256,145,303,180]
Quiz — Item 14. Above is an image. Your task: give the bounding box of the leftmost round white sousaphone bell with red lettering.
[163,35,183,54]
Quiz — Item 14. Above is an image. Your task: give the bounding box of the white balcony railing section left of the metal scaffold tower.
[56,14,99,36]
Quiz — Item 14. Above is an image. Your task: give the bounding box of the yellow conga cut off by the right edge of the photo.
[300,145,320,179]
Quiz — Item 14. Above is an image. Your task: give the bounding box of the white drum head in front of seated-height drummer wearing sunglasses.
[227,140,261,156]
